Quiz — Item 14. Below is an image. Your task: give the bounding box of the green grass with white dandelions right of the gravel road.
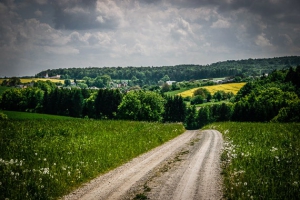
[205,122,300,199]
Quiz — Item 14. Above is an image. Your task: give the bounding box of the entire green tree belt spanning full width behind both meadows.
[0,66,300,129]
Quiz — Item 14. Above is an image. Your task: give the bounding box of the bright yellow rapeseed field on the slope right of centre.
[178,83,246,97]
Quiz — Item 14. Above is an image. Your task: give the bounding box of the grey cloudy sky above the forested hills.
[0,0,300,77]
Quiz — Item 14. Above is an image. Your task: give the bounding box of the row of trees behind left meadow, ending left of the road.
[0,82,186,122]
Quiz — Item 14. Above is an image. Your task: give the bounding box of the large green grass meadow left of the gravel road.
[0,119,184,199]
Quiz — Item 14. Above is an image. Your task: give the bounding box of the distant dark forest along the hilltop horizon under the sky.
[36,56,300,86]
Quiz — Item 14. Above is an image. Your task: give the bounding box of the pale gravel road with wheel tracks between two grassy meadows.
[63,130,223,200]
